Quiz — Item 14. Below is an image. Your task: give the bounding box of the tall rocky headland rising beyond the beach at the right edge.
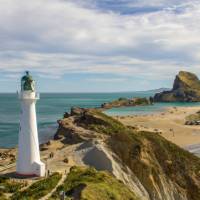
[154,71,200,102]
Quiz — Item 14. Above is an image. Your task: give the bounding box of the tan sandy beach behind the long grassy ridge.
[115,107,200,152]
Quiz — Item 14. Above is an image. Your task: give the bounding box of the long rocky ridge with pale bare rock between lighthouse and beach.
[55,109,200,200]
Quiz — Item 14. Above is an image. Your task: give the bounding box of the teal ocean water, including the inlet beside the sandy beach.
[0,92,200,148]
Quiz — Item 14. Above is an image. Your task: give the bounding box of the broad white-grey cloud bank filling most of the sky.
[0,0,200,86]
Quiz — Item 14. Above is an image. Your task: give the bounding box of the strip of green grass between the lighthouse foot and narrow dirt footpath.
[11,173,61,200]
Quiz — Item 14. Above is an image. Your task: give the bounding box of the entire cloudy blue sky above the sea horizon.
[0,0,200,92]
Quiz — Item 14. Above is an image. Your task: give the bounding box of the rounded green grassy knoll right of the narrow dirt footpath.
[51,167,138,200]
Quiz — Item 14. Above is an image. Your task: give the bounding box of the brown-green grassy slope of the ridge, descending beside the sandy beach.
[74,110,200,200]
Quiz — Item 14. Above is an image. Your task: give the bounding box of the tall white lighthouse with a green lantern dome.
[17,72,45,176]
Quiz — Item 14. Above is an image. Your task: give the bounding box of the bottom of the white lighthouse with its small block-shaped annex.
[17,161,45,177]
